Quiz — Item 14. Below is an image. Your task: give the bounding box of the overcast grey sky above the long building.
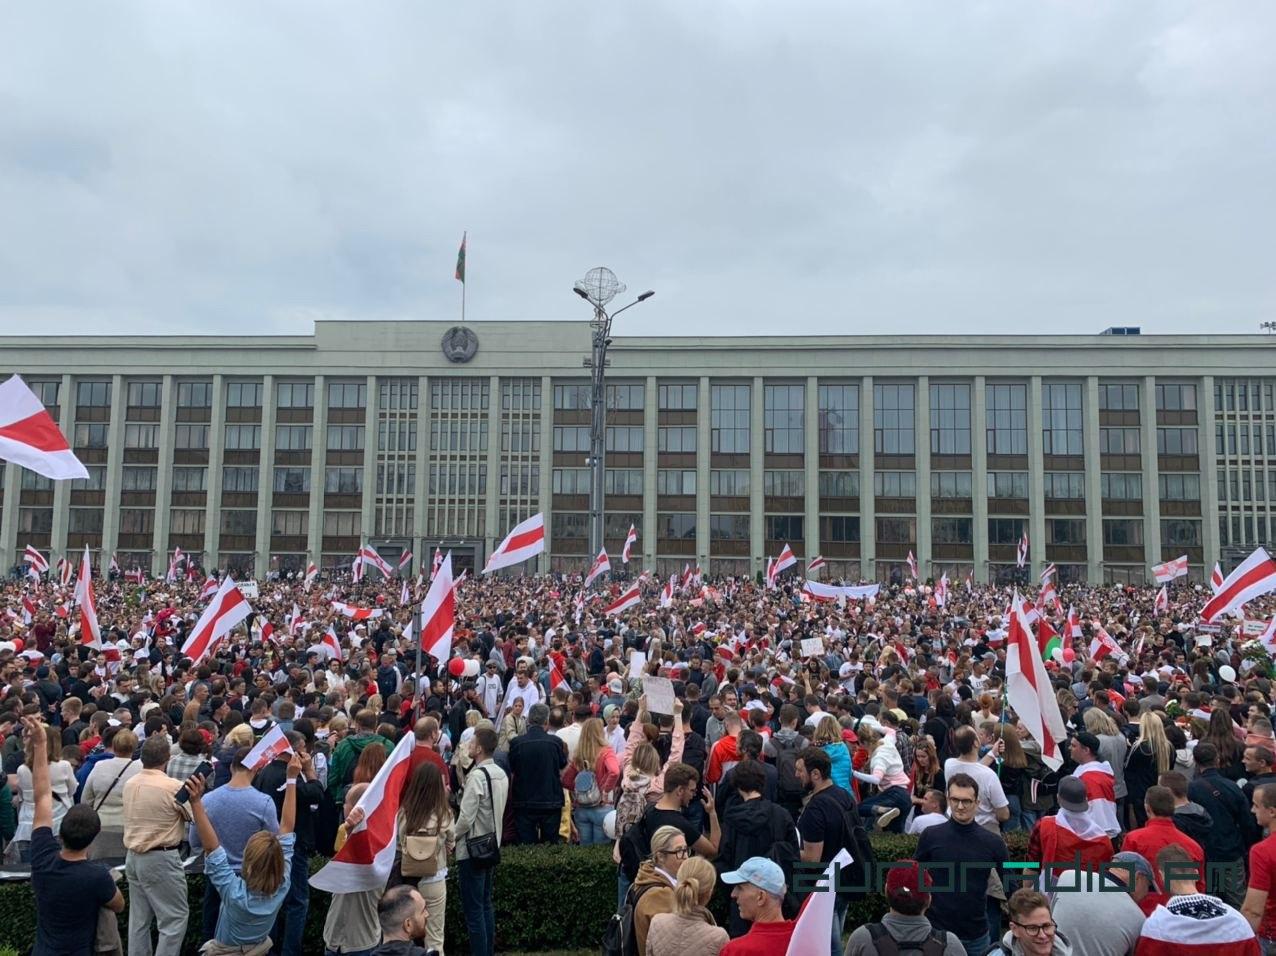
[0,0,1276,334]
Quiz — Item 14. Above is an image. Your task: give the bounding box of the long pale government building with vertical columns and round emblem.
[0,322,1276,583]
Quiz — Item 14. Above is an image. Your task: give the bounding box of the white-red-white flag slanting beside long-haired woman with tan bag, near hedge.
[310,734,416,893]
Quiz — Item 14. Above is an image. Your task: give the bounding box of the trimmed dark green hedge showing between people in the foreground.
[0,833,1027,953]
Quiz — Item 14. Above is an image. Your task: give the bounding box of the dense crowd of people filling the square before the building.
[7,559,1276,956]
